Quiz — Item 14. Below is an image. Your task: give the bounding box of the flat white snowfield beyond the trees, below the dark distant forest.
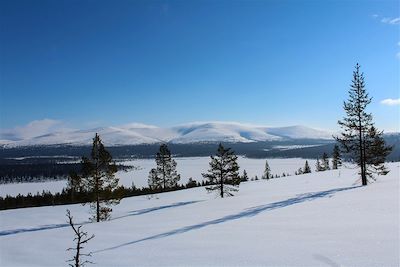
[0,157,315,196]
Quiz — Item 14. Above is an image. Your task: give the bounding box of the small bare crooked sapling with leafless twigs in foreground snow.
[67,210,94,267]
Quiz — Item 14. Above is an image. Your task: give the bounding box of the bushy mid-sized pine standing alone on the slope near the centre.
[202,144,240,198]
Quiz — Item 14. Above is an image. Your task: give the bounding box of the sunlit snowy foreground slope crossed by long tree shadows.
[0,163,400,267]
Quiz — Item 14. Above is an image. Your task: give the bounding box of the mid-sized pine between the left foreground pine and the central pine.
[148,144,181,190]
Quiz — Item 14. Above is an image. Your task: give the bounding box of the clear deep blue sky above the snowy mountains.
[0,0,400,131]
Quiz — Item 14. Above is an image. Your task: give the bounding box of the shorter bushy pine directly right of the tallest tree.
[365,126,393,177]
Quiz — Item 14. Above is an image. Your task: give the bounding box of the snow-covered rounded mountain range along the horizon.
[0,122,332,147]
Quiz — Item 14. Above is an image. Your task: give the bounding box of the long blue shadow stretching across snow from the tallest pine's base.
[94,186,360,253]
